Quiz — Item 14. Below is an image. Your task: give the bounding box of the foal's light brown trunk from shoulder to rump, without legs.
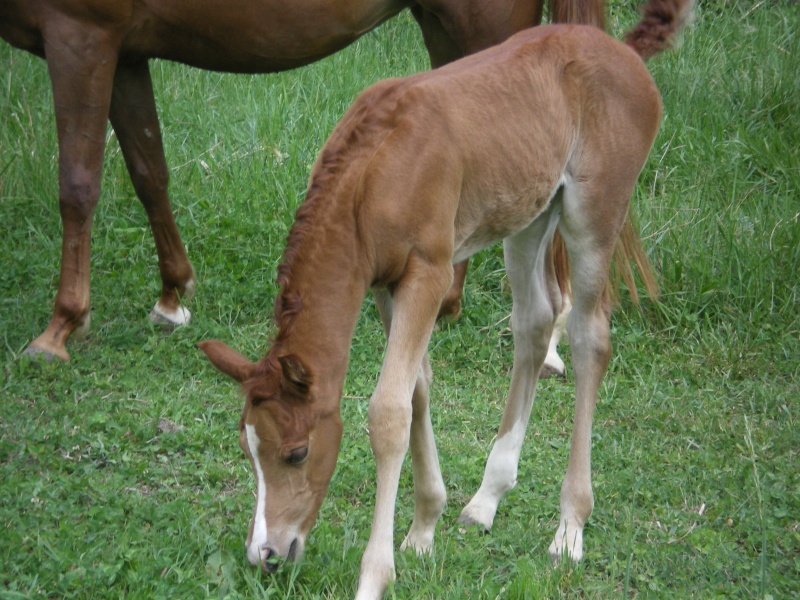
[337,25,661,260]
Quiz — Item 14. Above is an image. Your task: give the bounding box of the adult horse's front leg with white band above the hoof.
[110,60,194,325]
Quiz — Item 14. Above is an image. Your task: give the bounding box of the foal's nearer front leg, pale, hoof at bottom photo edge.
[356,256,452,600]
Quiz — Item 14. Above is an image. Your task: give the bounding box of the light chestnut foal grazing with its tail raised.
[201,0,692,598]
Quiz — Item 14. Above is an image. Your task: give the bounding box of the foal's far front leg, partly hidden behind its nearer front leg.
[374,288,452,553]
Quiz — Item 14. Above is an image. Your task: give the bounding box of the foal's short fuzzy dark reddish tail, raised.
[625,0,694,60]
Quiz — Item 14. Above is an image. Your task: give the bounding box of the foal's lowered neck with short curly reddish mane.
[268,94,394,402]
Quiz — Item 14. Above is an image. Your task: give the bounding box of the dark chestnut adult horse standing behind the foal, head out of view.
[0,0,603,360]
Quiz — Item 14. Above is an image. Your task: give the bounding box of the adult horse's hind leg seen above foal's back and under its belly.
[411,0,548,318]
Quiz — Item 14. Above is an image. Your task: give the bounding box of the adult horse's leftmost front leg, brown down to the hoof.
[26,18,118,361]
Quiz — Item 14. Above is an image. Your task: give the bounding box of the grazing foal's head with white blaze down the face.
[200,340,342,571]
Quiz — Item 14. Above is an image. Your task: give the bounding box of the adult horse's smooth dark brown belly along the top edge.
[132,0,411,72]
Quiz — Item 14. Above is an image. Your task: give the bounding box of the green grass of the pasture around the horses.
[0,2,800,600]
